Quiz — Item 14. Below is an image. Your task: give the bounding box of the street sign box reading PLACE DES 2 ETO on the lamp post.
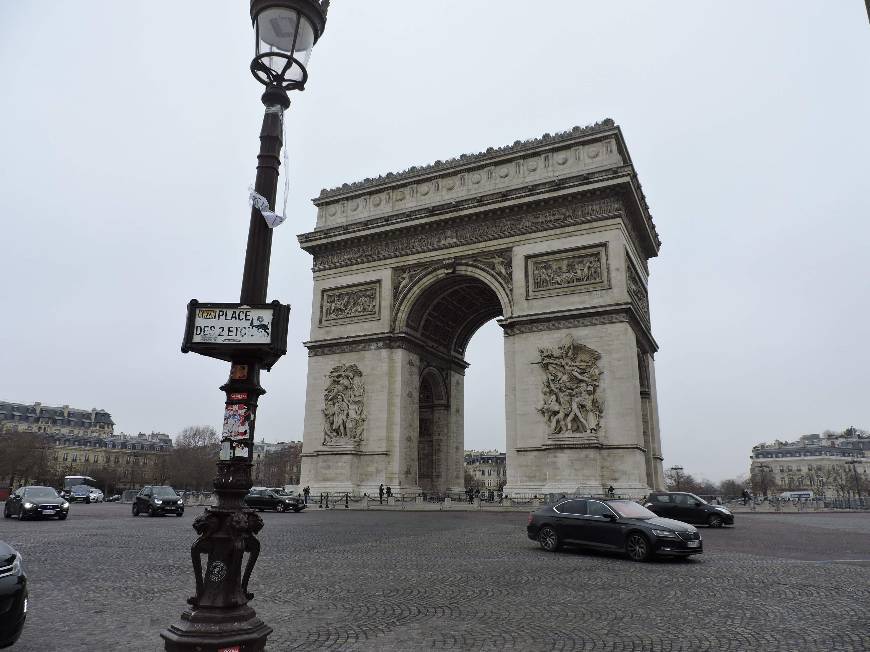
[181,299,290,375]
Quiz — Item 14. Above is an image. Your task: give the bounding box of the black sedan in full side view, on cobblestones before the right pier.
[526,498,704,561]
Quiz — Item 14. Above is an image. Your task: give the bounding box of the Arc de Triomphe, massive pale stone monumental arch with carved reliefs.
[299,120,663,495]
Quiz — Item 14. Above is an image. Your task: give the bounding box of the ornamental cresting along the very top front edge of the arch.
[313,118,618,200]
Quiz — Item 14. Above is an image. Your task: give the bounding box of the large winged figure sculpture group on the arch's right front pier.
[535,335,604,439]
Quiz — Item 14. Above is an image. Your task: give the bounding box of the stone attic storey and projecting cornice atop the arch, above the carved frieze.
[299,121,661,258]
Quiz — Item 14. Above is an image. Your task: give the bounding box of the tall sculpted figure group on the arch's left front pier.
[323,364,366,446]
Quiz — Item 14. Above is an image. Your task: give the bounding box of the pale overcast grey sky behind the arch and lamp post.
[0,0,870,480]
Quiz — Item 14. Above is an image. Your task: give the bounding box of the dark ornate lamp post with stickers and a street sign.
[160,0,329,652]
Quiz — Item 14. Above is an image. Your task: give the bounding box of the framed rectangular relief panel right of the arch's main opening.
[526,243,610,299]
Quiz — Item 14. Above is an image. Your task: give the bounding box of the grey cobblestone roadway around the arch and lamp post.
[0,504,870,652]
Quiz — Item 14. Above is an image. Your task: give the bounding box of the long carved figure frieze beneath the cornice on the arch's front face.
[313,197,624,272]
